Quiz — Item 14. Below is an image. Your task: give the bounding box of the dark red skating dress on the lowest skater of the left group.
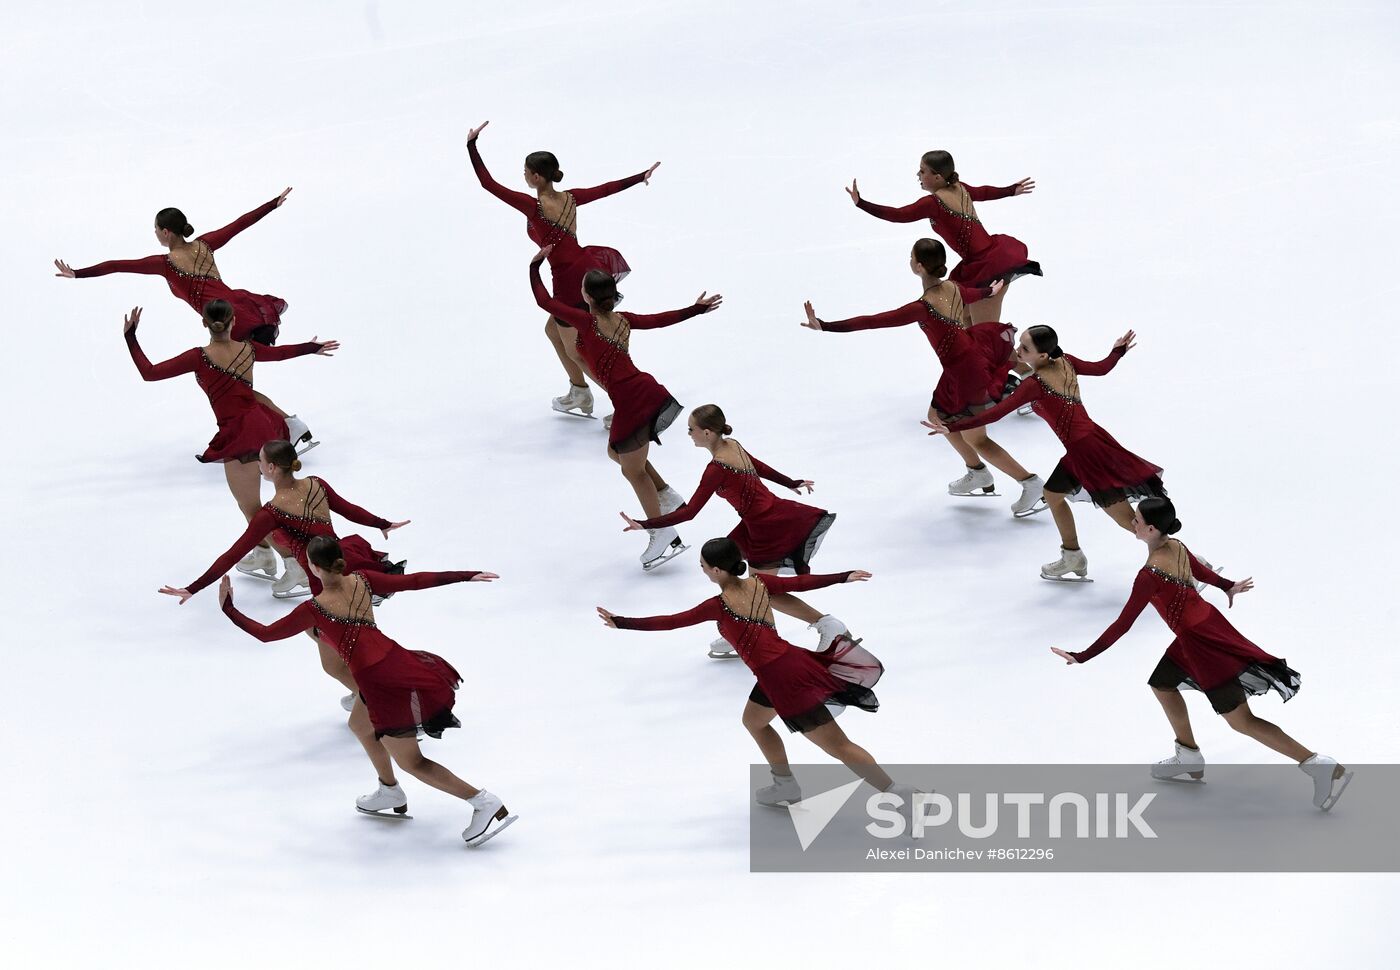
[224,571,476,738]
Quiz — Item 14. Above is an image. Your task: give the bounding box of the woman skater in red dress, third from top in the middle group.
[622,405,850,659]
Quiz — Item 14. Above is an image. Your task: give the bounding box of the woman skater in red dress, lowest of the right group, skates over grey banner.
[1050,498,1352,812]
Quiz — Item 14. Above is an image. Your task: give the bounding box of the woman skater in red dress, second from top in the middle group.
[529,246,724,570]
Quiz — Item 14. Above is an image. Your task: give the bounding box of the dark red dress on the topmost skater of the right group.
[857,182,1044,287]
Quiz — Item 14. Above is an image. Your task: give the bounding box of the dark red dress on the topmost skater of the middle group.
[466,139,645,307]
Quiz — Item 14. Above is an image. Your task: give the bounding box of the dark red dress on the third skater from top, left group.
[185,477,403,596]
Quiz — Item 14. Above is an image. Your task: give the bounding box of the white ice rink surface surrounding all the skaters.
[0,0,1400,967]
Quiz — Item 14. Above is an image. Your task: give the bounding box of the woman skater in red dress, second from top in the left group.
[123,300,340,540]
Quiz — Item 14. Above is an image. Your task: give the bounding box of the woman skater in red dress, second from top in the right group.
[802,239,1046,518]
